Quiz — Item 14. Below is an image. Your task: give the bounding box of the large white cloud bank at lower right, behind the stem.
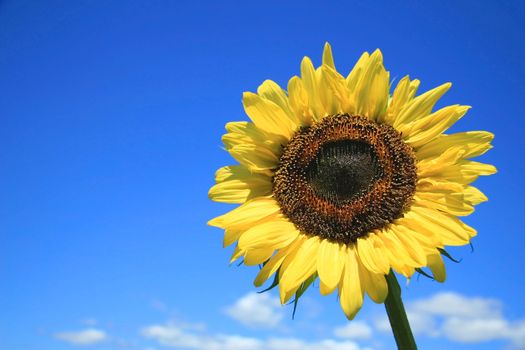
[375,292,525,349]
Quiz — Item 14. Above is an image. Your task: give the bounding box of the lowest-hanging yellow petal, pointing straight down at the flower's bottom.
[339,247,364,320]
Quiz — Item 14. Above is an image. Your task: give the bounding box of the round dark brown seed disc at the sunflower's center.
[273,114,417,244]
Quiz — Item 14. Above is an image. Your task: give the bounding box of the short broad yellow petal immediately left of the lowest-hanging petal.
[317,239,345,295]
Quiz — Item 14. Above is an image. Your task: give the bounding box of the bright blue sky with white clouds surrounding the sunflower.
[0,1,525,350]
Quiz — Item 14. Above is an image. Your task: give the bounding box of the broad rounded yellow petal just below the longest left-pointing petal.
[239,218,299,250]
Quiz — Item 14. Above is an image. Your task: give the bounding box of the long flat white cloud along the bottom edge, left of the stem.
[141,323,364,350]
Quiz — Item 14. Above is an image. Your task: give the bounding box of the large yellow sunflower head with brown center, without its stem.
[209,43,496,319]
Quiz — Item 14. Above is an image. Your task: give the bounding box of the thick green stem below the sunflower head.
[385,270,417,350]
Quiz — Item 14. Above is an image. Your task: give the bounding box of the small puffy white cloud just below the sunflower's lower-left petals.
[225,292,283,328]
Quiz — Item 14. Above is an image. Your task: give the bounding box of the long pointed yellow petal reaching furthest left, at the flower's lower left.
[208,197,281,229]
